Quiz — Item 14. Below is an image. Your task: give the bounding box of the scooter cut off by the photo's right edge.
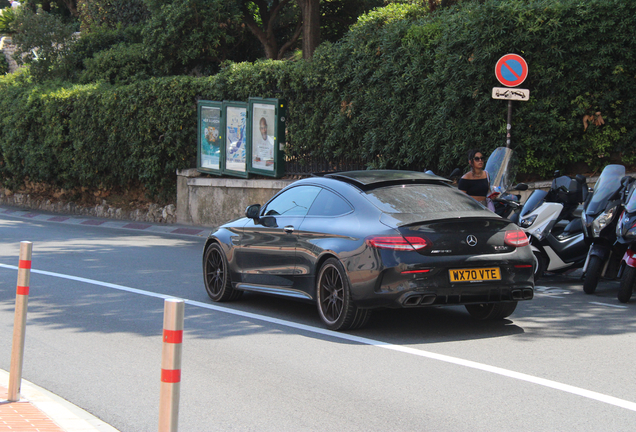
[616,181,636,303]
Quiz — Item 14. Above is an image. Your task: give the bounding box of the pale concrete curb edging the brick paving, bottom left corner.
[0,369,119,432]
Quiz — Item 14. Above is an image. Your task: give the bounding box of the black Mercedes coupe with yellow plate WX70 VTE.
[203,170,534,330]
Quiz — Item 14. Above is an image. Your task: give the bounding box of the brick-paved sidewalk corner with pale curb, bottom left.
[0,369,118,432]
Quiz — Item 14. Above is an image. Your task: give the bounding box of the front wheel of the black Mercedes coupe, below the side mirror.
[203,243,243,302]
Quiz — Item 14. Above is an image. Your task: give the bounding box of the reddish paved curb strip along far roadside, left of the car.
[0,206,213,237]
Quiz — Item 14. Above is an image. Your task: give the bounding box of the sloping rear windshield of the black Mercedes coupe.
[366,184,484,214]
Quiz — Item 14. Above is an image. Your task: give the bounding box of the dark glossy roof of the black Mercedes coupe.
[324,170,451,189]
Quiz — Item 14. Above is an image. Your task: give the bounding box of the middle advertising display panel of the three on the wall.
[223,102,250,177]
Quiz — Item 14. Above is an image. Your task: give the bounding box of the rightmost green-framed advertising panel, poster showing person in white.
[247,98,285,177]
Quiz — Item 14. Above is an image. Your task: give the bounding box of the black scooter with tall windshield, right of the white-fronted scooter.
[581,164,633,294]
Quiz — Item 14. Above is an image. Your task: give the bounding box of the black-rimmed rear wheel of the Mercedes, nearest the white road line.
[316,258,371,330]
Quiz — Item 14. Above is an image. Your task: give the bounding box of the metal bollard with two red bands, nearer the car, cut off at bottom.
[159,299,185,432]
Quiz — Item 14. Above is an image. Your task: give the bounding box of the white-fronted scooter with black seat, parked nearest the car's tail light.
[517,171,589,282]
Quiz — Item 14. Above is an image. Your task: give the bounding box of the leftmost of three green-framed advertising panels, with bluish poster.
[197,101,223,174]
